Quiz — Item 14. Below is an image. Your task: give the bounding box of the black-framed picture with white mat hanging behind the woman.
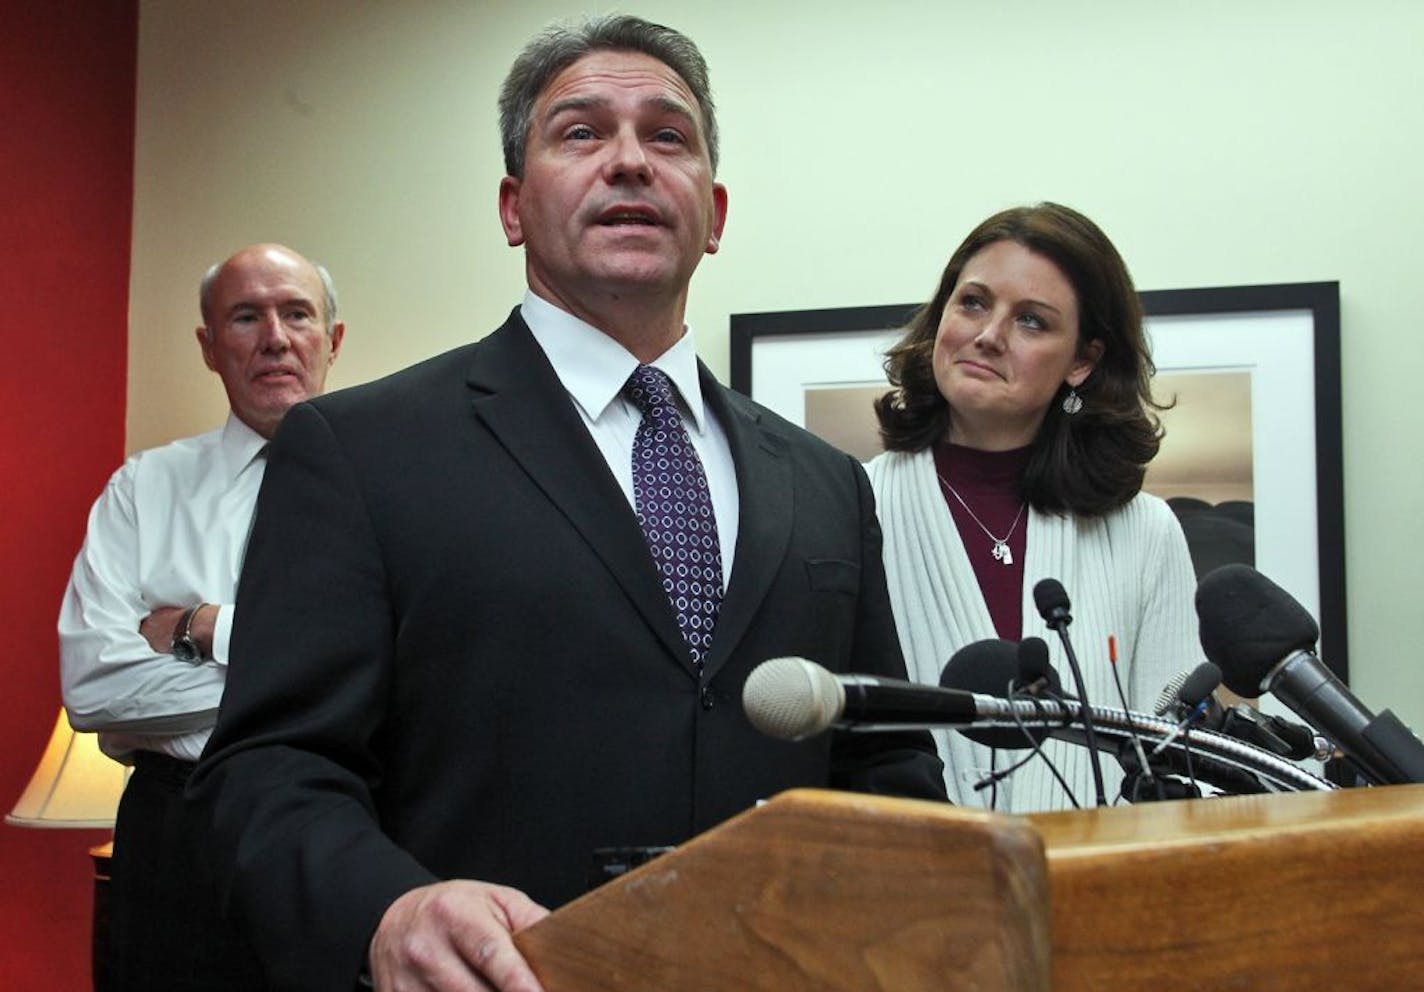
[731,282,1349,679]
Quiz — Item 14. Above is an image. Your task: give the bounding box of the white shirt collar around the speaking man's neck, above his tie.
[520,284,706,433]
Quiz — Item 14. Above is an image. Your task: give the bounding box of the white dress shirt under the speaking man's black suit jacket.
[520,292,740,592]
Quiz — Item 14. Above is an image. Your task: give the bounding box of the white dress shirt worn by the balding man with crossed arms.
[60,414,266,763]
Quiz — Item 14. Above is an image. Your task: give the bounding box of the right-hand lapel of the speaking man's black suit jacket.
[699,366,795,677]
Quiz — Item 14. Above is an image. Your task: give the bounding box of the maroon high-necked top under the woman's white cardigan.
[934,441,1030,640]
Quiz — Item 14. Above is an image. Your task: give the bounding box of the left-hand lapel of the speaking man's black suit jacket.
[468,312,692,672]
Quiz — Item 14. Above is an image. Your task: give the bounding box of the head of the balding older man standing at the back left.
[198,245,346,437]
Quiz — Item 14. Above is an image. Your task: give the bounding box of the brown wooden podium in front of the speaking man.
[515,786,1424,992]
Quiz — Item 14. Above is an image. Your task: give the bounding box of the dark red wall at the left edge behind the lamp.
[0,0,138,991]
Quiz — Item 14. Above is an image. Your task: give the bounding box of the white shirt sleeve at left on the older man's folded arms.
[58,458,224,734]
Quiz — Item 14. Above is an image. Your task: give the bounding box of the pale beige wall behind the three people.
[128,0,1424,729]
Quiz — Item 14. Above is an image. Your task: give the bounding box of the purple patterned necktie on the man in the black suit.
[624,366,722,670]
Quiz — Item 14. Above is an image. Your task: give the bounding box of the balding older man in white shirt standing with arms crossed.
[58,245,345,992]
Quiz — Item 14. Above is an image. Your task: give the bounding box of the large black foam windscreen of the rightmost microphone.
[1196,565,1320,697]
